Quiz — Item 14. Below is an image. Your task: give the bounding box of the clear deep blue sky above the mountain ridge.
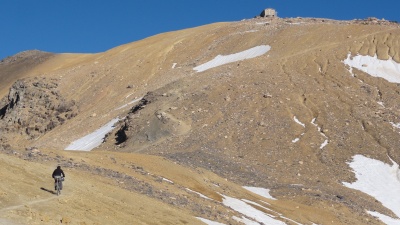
[0,0,400,59]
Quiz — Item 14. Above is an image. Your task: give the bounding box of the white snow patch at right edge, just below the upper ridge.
[343,54,400,83]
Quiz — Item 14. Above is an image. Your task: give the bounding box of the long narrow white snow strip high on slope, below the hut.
[193,45,271,72]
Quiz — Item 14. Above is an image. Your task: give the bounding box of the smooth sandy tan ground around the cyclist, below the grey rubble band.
[0,151,208,224]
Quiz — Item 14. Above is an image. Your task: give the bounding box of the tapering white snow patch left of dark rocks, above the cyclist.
[64,118,119,151]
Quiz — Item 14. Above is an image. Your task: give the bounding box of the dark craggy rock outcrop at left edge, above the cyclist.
[0,77,78,139]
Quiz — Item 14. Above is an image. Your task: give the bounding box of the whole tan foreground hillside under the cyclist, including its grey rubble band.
[0,151,362,224]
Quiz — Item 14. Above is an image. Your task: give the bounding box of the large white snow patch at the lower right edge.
[343,155,400,224]
